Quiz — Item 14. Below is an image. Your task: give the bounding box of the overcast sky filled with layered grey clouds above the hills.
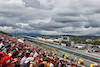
[0,0,100,36]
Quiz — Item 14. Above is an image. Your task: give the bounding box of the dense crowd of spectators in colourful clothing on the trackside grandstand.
[0,33,98,67]
